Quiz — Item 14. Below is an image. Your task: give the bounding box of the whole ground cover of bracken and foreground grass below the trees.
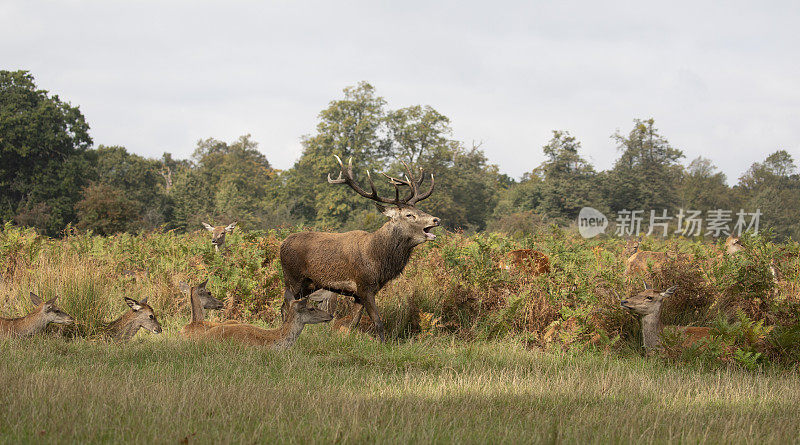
[0,225,800,443]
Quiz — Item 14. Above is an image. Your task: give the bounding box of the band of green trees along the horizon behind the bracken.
[0,71,800,239]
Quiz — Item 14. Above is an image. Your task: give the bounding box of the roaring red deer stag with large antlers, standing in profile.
[280,156,440,341]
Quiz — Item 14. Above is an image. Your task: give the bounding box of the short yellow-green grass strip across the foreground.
[0,321,800,444]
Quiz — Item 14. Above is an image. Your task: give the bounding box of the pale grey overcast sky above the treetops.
[0,1,800,182]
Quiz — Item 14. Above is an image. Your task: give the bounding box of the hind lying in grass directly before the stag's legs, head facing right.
[205,298,333,349]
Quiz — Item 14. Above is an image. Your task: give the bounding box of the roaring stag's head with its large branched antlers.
[328,155,440,245]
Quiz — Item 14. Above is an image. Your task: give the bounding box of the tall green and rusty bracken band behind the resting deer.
[0,225,800,368]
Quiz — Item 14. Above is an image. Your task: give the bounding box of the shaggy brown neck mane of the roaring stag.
[368,220,416,287]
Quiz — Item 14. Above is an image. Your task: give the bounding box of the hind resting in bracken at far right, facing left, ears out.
[622,283,711,353]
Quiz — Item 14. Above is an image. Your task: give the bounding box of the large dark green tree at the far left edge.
[0,71,93,235]
